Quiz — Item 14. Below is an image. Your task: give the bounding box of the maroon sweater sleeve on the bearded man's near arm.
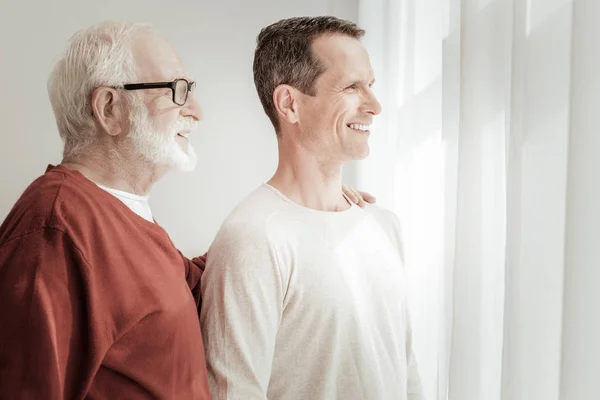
[0,228,107,400]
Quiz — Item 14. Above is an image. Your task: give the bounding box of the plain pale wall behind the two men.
[0,0,357,256]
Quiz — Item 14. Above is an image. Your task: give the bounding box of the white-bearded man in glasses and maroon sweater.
[0,22,370,399]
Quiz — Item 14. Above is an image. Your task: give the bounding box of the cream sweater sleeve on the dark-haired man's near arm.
[200,226,285,400]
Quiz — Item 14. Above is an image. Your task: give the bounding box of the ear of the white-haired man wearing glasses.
[91,87,128,136]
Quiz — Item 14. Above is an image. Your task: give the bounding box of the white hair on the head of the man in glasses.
[48,21,153,159]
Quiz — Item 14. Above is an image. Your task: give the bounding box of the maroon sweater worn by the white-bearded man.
[0,166,210,400]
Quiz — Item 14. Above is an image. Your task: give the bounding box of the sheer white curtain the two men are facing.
[352,0,600,400]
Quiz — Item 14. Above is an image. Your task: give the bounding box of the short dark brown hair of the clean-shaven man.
[253,16,365,135]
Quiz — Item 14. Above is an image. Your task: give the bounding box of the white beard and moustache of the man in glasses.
[129,99,198,171]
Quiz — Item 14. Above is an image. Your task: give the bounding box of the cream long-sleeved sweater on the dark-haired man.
[201,184,423,400]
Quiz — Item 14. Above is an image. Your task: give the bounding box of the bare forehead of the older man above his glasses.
[131,32,187,82]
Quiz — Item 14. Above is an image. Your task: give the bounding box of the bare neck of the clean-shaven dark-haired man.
[268,138,350,211]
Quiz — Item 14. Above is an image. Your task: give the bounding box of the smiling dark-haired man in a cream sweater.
[201,17,422,400]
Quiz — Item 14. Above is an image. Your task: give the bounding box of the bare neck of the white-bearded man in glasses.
[61,149,166,196]
